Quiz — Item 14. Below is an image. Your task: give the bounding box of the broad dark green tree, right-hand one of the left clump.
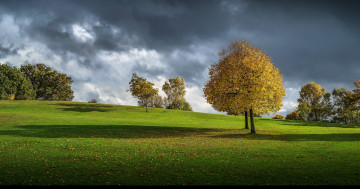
[20,64,74,101]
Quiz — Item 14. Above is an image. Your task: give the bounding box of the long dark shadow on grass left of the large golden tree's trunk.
[0,125,224,138]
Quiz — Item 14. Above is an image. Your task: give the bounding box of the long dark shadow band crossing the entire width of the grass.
[0,125,360,141]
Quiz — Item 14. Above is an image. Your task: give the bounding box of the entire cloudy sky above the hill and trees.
[0,0,360,116]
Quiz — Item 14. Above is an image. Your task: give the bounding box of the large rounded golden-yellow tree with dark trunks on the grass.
[203,41,285,133]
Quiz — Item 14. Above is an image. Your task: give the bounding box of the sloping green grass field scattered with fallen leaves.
[0,101,360,185]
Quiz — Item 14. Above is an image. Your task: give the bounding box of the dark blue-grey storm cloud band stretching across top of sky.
[1,0,360,80]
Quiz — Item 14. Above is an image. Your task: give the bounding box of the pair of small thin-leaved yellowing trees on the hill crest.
[128,73,192,112]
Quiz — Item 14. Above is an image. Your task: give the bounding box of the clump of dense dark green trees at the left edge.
[0,64,74,101]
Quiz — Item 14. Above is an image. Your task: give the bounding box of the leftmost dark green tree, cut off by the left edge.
[0,64,36,100]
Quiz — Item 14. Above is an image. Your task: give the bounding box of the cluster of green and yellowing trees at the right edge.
[285,80,360,124]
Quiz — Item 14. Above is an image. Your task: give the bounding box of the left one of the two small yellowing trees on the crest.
[129,73,158,112]
